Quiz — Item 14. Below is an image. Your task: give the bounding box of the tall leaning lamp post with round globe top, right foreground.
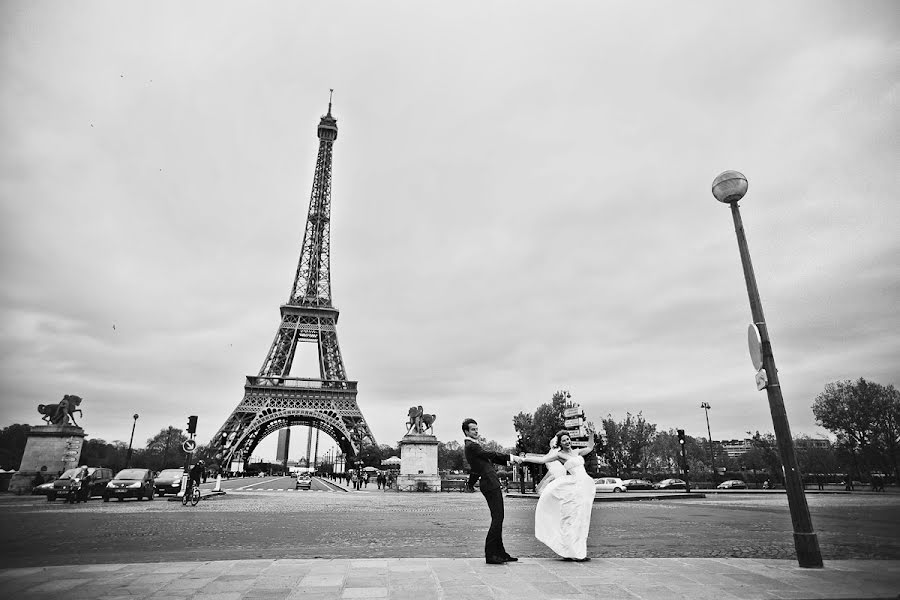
[712,171,822,567]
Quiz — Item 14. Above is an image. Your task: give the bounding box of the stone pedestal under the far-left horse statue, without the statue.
[9,425,85,494]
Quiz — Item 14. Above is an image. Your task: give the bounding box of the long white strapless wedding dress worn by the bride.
[534,454,596,559]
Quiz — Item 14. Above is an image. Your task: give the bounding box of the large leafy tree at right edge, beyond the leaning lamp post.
[812,377,900,479]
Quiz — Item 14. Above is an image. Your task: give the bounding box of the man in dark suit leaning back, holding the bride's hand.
[463,419,522,565]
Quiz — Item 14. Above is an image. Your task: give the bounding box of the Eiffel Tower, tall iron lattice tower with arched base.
[211,90,375,469]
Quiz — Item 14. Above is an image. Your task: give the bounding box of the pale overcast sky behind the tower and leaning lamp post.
[0,1,900,458]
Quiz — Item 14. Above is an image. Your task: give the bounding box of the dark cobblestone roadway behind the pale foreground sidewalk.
[0,490,900,567]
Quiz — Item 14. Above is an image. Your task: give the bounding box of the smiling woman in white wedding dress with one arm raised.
[524,431,596,562]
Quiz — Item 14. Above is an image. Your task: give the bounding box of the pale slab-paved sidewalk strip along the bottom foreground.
[0,558,900,600]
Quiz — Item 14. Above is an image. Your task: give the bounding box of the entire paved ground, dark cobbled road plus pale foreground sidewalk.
[0,479,900,600]
